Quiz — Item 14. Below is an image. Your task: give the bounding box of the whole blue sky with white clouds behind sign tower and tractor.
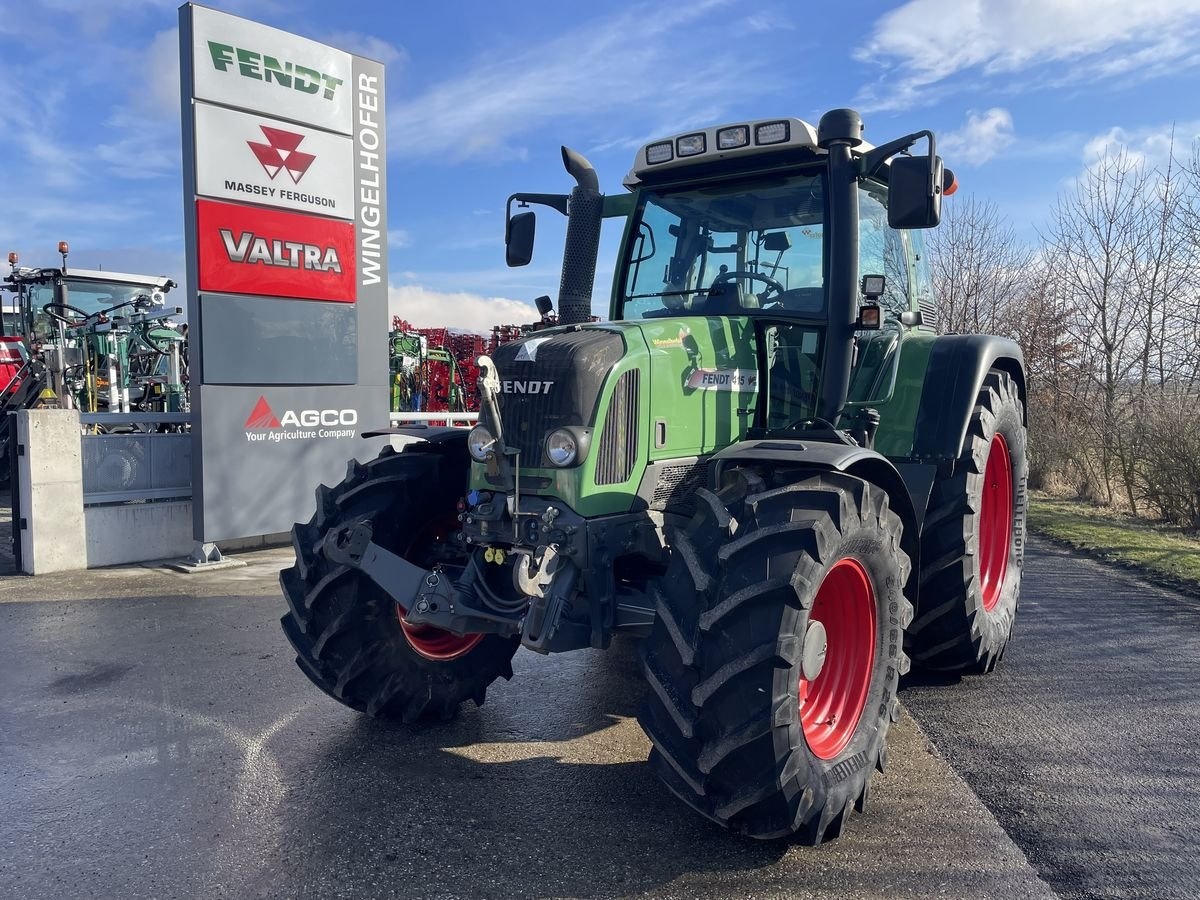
[0,0,1200,329]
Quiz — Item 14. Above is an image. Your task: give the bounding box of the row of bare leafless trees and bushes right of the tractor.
[930,140,1200,527]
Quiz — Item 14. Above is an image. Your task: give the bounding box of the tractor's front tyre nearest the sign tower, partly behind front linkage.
[280,448,520,721]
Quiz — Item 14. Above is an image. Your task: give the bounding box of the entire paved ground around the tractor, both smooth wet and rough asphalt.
[0,532,1200,900]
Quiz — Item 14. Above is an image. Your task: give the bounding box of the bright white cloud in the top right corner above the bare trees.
[856,0,1200,109]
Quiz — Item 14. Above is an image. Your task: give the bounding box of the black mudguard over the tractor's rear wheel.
[912,335,1026,463]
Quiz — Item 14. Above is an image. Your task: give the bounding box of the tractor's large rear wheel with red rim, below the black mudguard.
[911,370,1028,673]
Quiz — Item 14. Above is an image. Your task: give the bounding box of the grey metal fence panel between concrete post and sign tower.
[79,413,192,506]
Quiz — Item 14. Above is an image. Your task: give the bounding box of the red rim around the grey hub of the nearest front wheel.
[799,559,876,760]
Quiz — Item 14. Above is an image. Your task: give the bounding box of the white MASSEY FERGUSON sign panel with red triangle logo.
[196,103,354,220]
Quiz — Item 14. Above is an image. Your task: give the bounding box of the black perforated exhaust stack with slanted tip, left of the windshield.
[558,146,604,325]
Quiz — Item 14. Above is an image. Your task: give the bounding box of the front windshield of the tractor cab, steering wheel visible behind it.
[619,173,826,319]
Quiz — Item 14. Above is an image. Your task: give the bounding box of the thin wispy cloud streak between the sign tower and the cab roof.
[389,0,773,162]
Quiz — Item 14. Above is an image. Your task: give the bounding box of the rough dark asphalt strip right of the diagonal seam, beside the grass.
[901,541,1200,899]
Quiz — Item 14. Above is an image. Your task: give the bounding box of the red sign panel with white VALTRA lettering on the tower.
[196,200,358,304]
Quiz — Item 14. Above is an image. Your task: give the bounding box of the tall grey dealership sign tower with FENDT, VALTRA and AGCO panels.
[179,4,388,542]
